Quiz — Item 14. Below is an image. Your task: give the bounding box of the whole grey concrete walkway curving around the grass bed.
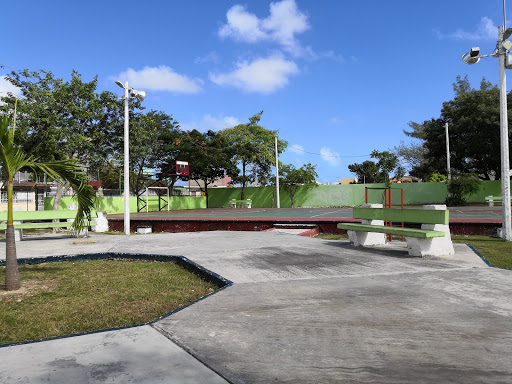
[0,231,512,383]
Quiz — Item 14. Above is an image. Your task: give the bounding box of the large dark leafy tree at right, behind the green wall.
[411,76,512,179]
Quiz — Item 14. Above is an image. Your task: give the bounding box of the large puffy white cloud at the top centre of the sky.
[219,0,310,55]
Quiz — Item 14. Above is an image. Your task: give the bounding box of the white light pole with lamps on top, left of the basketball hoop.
[116,81,146,236]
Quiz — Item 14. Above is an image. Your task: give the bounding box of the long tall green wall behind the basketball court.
[208,181,501,208]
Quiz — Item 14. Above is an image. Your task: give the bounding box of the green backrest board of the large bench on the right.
[353,207,449,225]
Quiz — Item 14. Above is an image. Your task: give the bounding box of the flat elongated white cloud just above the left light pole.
[112,65,203,93]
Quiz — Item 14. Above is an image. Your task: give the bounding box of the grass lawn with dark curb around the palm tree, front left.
[0,260,219,344]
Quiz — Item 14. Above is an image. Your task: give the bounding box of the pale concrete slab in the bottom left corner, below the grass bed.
[0,326,227,384]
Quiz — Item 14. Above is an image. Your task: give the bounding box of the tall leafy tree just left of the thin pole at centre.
[221,111,288,200]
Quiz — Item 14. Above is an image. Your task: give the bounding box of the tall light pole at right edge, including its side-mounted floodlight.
[462,26,512,241]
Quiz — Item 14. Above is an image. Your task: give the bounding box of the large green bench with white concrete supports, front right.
[338,204,454,257]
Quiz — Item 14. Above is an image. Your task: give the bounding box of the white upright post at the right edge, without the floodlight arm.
[498,26,512,241]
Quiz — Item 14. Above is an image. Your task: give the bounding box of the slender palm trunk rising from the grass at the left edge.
[5,180,21,291]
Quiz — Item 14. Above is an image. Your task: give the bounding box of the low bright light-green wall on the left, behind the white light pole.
[44,196,206,213]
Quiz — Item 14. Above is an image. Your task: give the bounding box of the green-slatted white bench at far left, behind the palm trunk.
[0,210,98,241]
